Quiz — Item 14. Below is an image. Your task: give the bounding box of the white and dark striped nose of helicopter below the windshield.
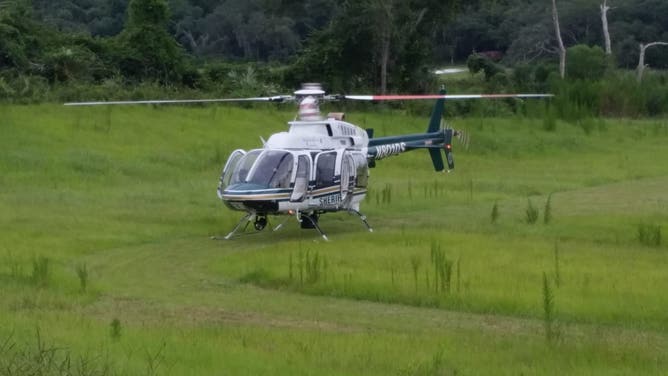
[218,183,290,213]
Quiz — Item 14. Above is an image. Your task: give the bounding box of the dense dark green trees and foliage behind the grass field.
[0,0,668,116]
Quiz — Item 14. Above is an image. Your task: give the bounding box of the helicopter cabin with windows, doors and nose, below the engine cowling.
[218,148,368,214]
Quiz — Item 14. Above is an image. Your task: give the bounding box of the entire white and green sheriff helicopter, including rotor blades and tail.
[65,84,551,240]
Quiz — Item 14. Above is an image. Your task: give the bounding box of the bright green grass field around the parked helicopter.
[0,101,668,375]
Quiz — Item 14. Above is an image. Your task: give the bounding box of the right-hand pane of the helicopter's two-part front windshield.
[247,150,294,188]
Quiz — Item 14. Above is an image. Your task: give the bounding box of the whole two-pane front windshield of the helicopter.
[233,150,294,188]
